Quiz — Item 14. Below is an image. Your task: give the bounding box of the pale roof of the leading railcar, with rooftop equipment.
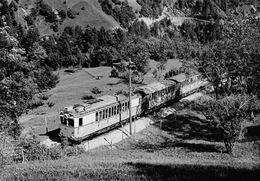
[63,95,137,117]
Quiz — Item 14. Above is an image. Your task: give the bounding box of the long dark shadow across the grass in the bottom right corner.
[128,163,260,181]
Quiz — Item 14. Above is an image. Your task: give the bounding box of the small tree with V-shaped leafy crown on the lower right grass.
[192,95,255,154]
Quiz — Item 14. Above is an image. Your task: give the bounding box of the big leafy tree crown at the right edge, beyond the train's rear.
[196,16,260,98]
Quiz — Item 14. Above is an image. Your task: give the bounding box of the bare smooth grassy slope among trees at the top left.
[17,0,119,35]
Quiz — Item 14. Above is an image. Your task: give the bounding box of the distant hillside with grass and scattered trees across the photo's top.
[3,0,260,36]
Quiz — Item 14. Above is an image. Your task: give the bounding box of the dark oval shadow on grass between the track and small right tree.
[157,114,222,141]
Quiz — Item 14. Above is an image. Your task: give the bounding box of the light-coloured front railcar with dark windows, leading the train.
[60,95,141,141]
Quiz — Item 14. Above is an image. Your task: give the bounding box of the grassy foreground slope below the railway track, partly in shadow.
[0,125,260,180]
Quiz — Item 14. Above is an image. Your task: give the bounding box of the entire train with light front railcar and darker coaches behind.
[60,73,209,142]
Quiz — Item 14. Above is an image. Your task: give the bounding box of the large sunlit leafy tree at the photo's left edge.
[0,27,57,136]
